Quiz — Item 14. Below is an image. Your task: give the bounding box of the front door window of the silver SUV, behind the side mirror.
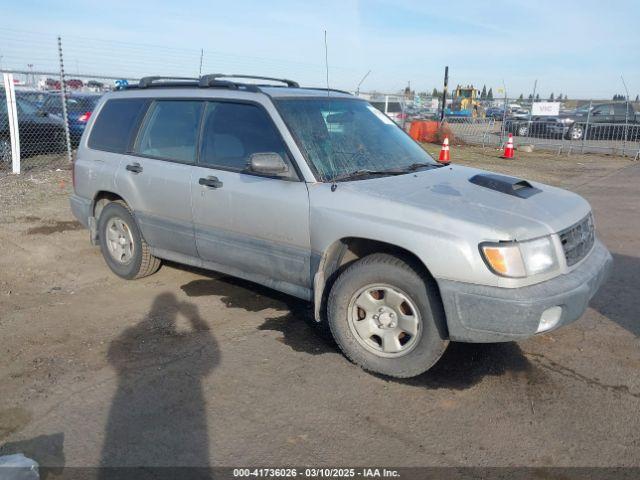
[199,102,287,171]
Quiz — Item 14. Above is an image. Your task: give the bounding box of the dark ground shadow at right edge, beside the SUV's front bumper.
[590,253,640,337]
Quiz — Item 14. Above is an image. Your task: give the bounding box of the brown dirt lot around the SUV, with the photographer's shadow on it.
[0,146,640,466]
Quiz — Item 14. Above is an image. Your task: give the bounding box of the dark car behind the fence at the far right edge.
[549,102,640,141]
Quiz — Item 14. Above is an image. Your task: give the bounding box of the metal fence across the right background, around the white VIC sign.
[403,95,640,160]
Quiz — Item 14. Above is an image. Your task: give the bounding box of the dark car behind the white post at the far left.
[0,96,66,165]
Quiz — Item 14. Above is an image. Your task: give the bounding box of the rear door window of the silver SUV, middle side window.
[135,100,203,163]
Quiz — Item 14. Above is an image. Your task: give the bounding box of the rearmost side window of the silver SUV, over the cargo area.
[89,98,147,153]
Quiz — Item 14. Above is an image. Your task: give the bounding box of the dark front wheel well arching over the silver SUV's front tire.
[314,237,449,338]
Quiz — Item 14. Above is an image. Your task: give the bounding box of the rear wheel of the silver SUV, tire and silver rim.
[98,201,160,280]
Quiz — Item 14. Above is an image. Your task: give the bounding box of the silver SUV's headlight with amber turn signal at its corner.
[480,237,558,278]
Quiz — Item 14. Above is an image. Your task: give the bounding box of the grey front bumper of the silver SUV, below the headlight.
[438,240,613,343]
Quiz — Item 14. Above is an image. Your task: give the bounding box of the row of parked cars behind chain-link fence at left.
[0,90,101,164]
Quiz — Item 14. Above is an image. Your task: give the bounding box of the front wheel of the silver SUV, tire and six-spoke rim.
[327,253,448,378]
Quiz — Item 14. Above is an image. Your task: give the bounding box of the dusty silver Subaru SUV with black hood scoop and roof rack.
[71,75,611,377]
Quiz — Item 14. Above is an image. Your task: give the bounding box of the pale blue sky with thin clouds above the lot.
[0,0,640,98]
